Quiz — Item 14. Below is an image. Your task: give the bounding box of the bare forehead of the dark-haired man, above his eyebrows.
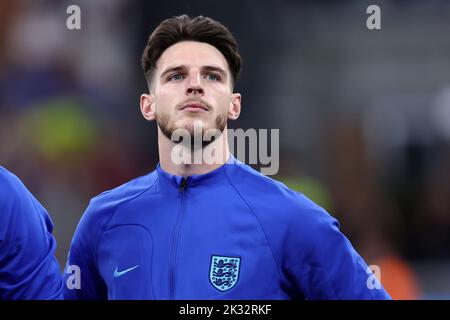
[156,41,228,72]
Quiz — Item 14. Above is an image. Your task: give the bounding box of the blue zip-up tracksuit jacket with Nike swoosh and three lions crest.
[64,156,390,299]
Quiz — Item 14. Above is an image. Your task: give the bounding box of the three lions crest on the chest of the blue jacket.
[209,256,241,291]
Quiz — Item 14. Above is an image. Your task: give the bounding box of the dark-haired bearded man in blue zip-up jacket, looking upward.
[65,15,389,299]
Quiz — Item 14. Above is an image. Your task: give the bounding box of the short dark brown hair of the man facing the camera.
[141,15,241,86]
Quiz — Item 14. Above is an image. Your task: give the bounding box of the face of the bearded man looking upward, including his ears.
[141,41,240,145]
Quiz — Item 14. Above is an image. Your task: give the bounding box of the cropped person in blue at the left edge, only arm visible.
[0,167,63,300]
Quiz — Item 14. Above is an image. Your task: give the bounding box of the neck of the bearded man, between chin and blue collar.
[158,127,230,177]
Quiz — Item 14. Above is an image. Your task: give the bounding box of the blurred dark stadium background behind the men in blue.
[0,0,450,299]
